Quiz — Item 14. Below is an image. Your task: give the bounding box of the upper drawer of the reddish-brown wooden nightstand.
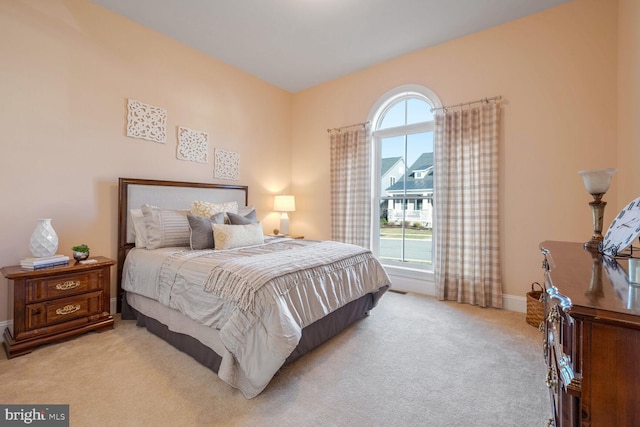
[25,270,102,303]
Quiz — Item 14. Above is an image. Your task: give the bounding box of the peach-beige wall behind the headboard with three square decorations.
[0,0,291,322]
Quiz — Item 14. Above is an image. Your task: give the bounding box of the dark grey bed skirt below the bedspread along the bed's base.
[122,286,389,373]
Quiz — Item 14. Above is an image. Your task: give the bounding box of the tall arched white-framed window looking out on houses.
[369,85,441,270]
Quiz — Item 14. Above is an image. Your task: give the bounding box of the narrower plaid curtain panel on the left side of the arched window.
[330,125,371,248]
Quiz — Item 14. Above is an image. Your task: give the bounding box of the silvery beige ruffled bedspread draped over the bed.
[123,239,390,398]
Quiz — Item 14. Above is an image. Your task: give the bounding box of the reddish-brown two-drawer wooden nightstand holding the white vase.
[0,256,116,358]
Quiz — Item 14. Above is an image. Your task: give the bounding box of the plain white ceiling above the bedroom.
[91,0,570,92]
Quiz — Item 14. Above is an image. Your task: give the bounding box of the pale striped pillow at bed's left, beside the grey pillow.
[141,204,191,249]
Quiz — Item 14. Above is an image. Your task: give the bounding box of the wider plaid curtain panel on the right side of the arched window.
[434,103,502,308]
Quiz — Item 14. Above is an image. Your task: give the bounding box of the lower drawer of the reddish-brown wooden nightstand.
[25,291,103,330]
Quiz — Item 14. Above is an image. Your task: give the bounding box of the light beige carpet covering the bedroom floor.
[0,293,550,427]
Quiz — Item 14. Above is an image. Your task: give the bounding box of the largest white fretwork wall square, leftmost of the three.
[127,99,167,144]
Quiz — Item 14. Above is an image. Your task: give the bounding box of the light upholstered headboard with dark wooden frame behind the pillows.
[116,178,249,312]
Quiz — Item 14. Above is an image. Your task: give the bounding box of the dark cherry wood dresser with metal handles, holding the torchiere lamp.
[540,241,640,427]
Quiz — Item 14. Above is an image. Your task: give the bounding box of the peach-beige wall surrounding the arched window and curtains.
[292,0,620,297]
